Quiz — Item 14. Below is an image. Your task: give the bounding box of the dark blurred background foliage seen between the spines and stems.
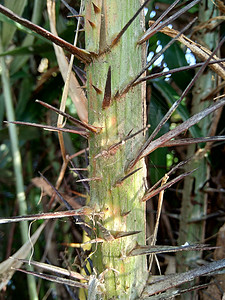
[0,0,225,299]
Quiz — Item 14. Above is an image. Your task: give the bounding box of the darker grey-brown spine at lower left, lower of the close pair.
[15,268,88,289]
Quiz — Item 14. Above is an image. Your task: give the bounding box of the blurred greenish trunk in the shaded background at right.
[177,0,218,300]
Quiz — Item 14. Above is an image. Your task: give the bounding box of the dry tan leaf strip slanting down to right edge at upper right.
[149,21,225,80]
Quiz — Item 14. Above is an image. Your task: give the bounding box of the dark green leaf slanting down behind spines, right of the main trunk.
[153,80,202,137]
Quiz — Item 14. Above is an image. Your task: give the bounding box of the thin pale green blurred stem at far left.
[0,39,38,300]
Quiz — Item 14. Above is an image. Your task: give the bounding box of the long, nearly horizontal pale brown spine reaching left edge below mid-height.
[0,206,93,224]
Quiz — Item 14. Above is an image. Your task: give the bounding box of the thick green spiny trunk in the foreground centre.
[85,0,147,299]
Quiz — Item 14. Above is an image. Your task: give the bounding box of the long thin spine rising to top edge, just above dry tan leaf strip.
[138,0,200,44]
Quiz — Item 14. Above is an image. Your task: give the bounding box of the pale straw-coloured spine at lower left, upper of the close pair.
[13,259,88,280]
